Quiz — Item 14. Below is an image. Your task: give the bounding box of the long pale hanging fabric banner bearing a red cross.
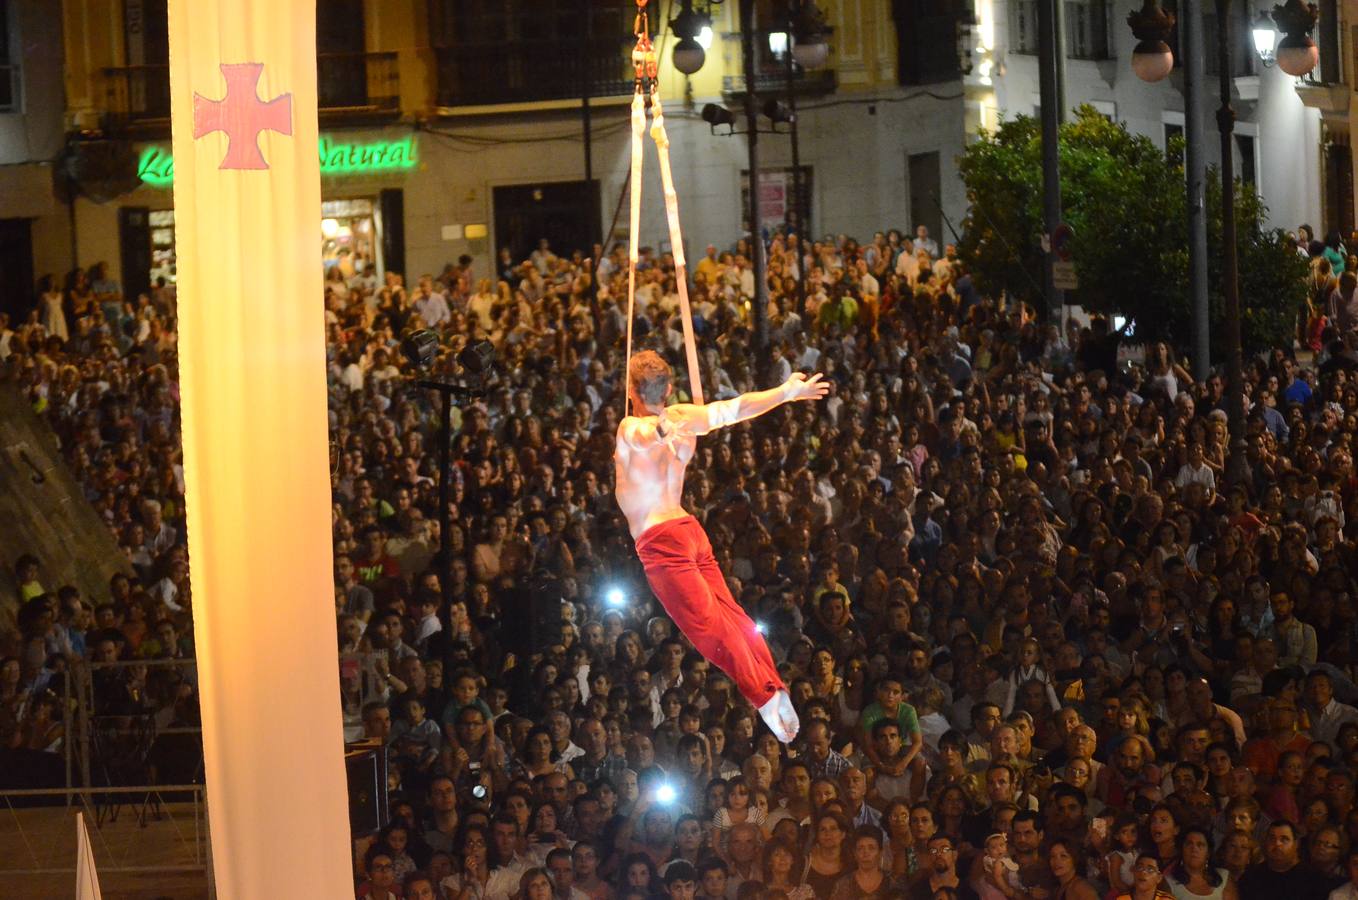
[166,0,353,900]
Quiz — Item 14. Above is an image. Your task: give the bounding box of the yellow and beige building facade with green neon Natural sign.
[0,0,966,312]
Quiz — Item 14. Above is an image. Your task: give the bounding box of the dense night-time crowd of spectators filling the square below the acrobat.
[0,217,1358,900]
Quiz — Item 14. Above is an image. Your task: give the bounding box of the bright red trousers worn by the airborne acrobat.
[637,516,784,709]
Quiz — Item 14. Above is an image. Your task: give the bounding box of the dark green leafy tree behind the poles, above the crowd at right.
[957,106,1306,360]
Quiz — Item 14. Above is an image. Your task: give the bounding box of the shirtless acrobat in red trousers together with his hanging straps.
[614,0,828,744]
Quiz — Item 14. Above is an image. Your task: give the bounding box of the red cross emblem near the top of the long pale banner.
[193,62,292,168]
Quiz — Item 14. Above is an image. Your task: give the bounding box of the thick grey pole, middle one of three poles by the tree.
[1179,0,1211,381]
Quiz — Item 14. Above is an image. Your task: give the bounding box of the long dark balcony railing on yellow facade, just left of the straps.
[435,39,631,107]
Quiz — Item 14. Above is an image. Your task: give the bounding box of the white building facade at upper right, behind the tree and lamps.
[967,0,1358,236]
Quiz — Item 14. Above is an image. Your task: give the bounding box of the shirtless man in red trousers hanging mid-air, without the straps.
[614,350,828,744]
